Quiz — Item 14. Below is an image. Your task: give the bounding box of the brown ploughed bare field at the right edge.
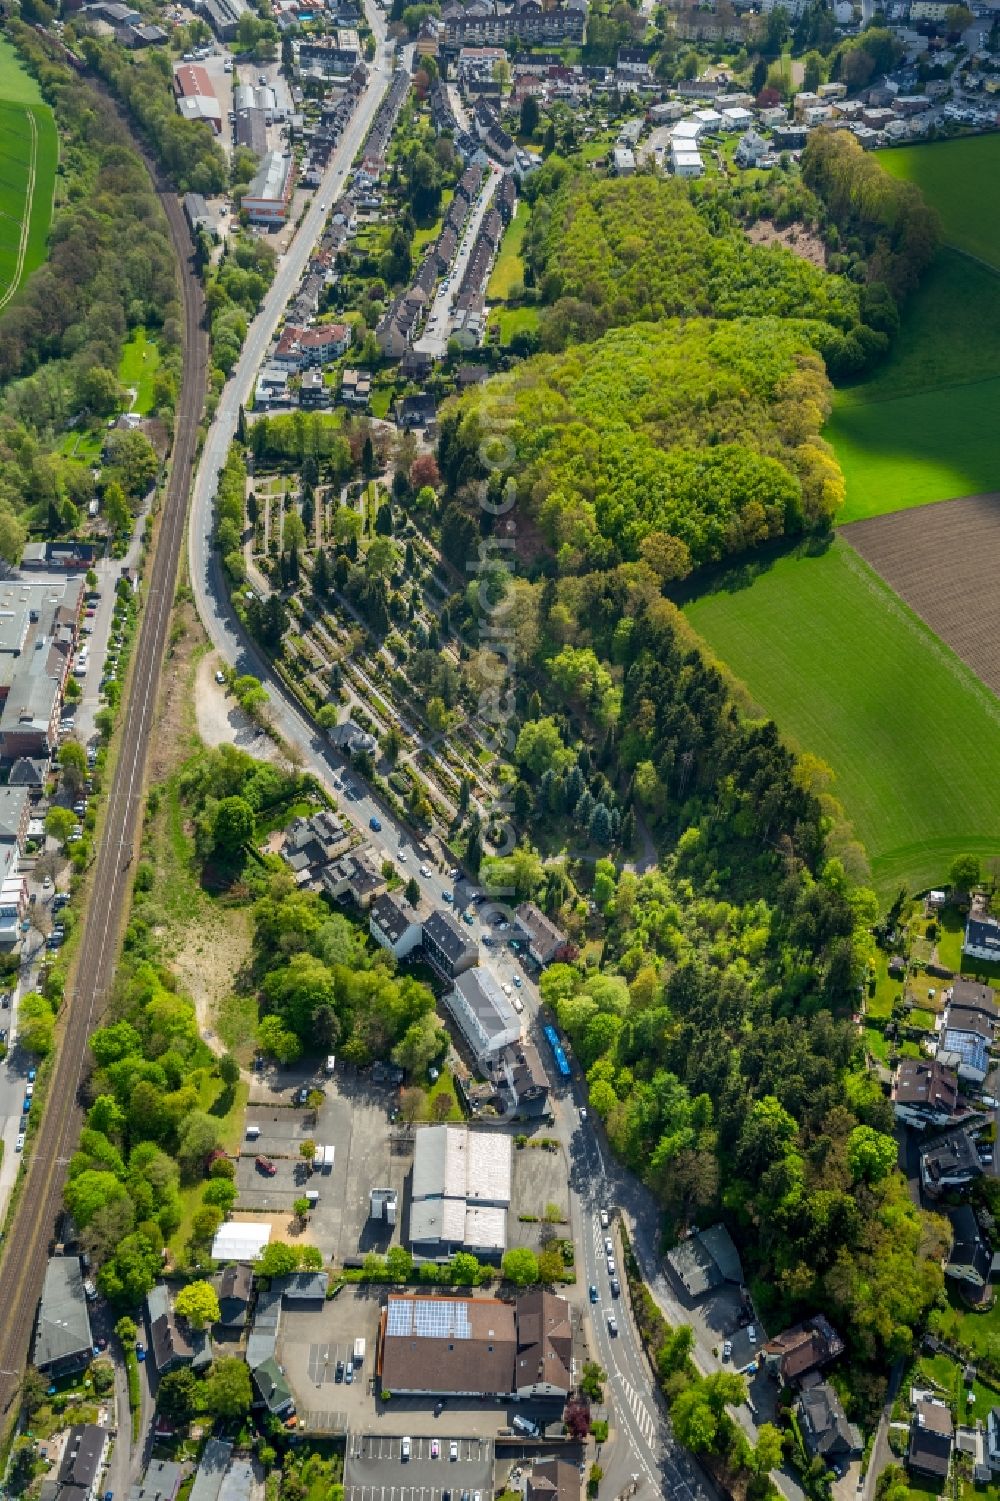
[839,491,1000,696]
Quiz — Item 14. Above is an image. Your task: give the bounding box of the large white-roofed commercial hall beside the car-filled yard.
[410,1126,514,1256]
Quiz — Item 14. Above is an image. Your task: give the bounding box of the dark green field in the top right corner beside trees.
[878,135,1000,270]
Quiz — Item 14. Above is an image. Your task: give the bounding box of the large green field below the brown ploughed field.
[686,542,1000,895]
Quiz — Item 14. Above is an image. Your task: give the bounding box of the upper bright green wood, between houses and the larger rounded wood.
[524,168,887,377]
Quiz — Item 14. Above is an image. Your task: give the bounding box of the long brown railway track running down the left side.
[0,162,209,1433]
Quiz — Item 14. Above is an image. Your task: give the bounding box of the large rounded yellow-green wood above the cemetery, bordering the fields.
[438,318,844,578]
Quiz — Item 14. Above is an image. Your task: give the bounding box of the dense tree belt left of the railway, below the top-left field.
[0,21,180,561]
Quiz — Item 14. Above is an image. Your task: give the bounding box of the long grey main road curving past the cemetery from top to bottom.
[188,17,790,1501]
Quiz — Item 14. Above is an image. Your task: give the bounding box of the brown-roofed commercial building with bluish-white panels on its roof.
[377,1292,574,1400]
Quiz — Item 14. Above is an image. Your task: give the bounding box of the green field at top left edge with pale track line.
[0,38,59,308]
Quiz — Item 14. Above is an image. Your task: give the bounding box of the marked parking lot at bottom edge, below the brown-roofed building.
[344,1433,494,1501]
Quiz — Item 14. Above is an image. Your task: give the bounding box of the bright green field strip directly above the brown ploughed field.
[823,378,1000,522]
